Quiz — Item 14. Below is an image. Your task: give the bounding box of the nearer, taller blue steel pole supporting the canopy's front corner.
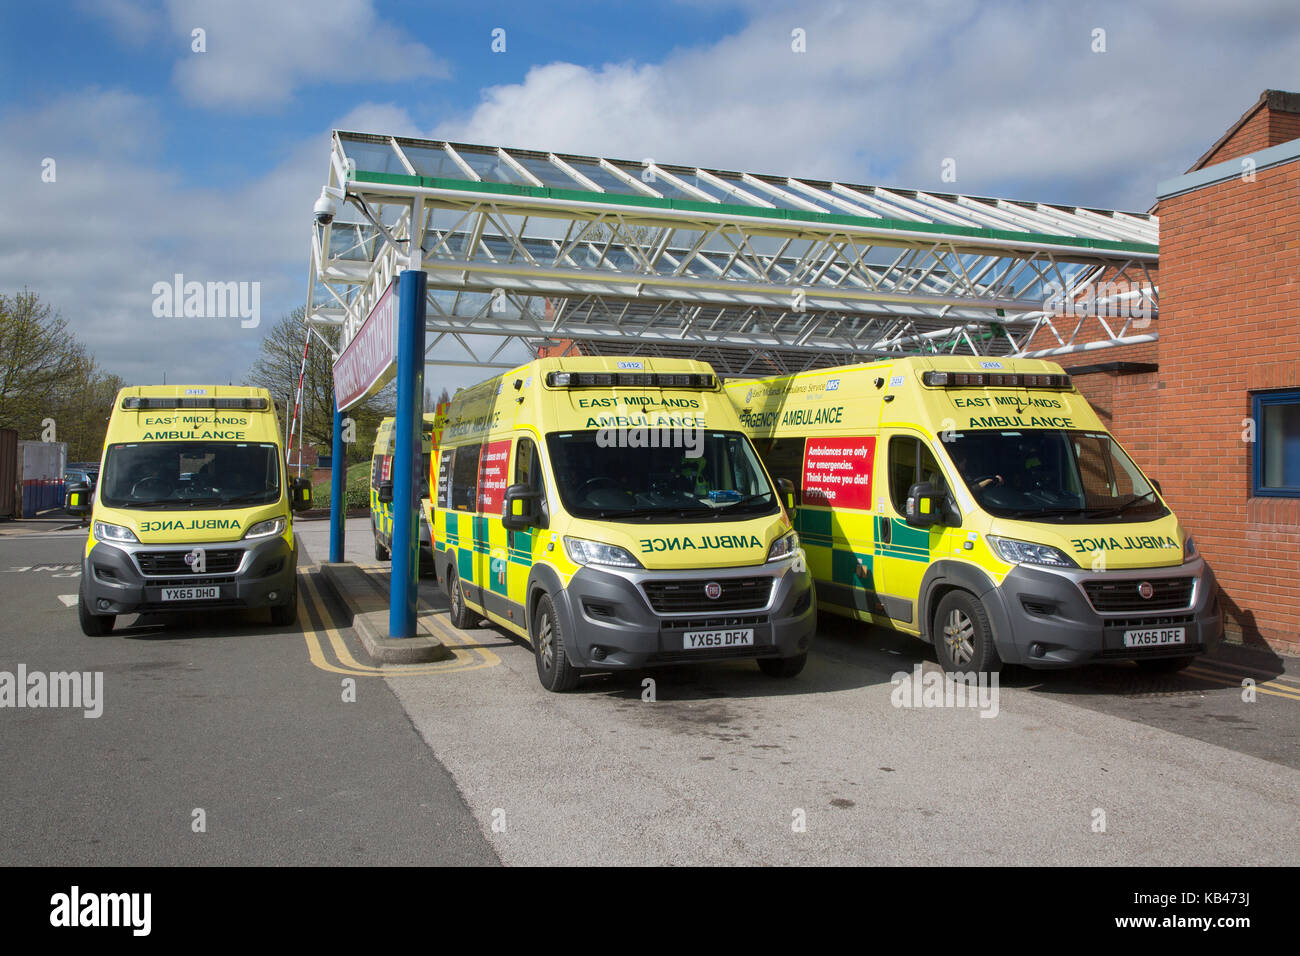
[389,269,428,637]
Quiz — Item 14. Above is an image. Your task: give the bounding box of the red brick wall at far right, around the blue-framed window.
[1153,161,1300,653]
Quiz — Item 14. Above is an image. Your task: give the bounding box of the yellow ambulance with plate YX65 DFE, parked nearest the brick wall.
[727,356,1223,672]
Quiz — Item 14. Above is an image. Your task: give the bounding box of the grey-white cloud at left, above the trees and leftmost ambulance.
[0,90,329,382]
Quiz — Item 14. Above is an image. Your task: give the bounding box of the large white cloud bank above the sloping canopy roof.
[437,0,1300,208]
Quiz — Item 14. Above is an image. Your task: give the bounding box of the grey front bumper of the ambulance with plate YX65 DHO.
[82,535,298,614]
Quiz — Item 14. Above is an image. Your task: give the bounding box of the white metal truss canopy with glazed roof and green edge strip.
[308,131,1158,375]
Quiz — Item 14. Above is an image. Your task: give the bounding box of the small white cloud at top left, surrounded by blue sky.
[168,0,449,109]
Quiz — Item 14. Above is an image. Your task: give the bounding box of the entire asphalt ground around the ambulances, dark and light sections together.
[0,519,1300,865]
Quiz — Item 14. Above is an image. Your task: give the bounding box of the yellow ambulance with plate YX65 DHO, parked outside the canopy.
[68,385,311,636]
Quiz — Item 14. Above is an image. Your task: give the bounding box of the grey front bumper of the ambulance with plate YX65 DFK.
[551,558,816,670]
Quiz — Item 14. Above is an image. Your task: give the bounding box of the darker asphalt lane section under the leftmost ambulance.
[0,522,497,865]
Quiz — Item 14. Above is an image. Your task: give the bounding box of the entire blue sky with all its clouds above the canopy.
[0,0,1300,385]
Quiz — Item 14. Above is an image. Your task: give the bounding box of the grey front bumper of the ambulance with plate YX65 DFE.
[983,557,1223,669]
